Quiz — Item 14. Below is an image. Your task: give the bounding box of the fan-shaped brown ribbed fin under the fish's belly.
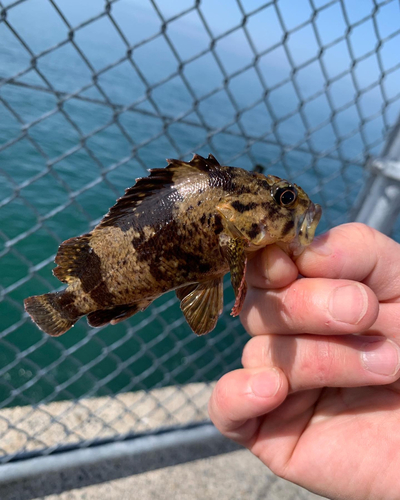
[176,278,224,335]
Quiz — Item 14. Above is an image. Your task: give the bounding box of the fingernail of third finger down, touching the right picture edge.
[361,340,400,376]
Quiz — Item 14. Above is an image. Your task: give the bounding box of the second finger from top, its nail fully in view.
[240,278,379,335]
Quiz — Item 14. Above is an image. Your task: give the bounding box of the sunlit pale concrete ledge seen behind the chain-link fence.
[0,383,214,459]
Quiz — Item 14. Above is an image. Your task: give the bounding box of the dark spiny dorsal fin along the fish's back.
[99,154,219,227]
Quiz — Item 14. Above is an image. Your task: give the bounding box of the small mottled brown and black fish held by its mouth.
[24,154,322,336]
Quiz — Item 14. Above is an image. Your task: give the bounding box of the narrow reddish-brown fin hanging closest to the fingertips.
[220,233,247,316]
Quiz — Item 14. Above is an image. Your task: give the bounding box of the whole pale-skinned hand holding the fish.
[209,223,400,500]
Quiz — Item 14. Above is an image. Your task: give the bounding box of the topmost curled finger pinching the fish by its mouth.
[296,223,400,301]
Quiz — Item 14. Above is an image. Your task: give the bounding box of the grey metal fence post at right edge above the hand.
[352,116,400,234]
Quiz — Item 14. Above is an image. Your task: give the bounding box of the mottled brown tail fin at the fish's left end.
[24,292,79,337]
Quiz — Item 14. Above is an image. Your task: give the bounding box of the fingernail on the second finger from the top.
[328,283,368,325]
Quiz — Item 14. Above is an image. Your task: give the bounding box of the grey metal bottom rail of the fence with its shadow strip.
[0,424,240,500]
